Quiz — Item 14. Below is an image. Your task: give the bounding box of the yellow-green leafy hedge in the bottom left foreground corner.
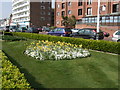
[0,51,31,89]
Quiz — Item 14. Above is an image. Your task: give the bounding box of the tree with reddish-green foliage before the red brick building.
[62,15,76,28]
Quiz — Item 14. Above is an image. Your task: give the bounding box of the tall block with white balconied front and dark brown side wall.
[12,0,52,27]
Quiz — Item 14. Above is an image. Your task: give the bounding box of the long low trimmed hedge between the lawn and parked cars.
[12,32,120,54]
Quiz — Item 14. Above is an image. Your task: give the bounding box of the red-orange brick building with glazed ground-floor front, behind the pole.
[54,0,120,28]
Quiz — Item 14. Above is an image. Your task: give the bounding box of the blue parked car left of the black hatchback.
[48,28,72,36]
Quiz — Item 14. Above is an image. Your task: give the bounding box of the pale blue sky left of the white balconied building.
[0,0,54,19]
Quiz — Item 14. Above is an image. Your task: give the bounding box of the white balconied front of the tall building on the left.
[12,0,30,26]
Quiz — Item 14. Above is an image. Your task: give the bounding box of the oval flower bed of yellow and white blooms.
[25,40,90,60]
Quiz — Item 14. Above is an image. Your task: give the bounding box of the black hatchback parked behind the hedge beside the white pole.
[70,28,104,40]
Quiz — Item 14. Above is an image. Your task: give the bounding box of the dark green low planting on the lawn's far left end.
[2,35,26,41]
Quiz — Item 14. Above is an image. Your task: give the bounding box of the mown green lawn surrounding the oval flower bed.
[2,40,118,88]
